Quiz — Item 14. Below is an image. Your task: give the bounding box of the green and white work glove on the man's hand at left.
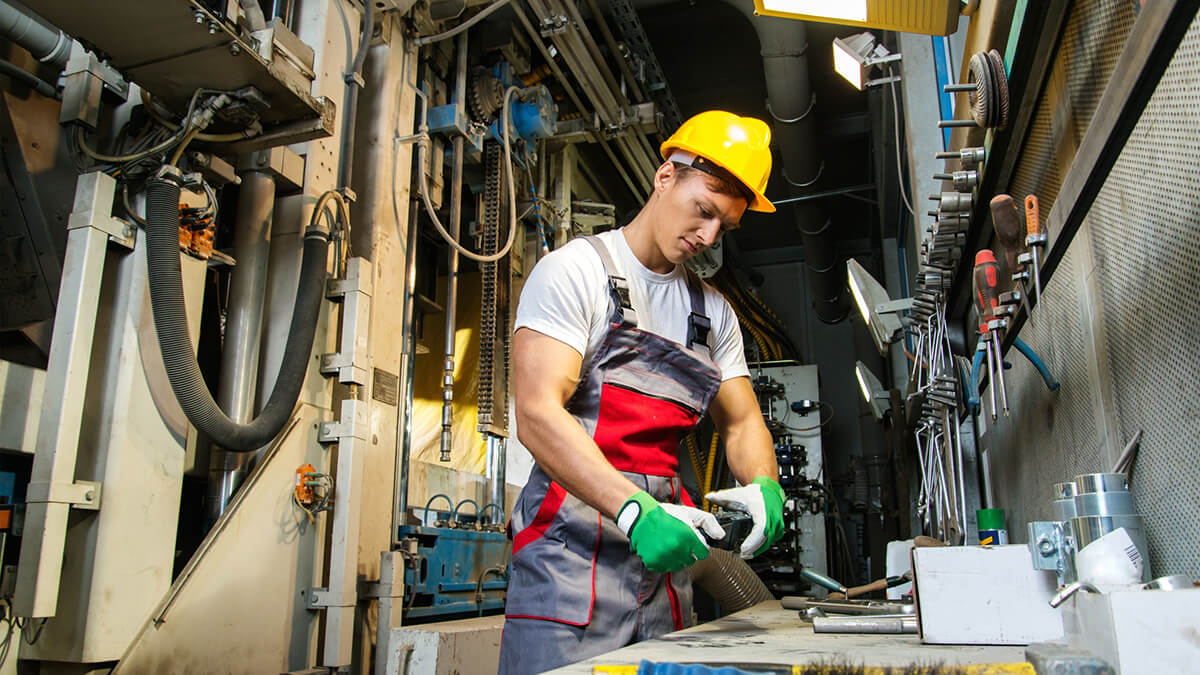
[617,490,725,572]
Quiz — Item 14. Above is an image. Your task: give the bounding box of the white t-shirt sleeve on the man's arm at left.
[512,240,605,357]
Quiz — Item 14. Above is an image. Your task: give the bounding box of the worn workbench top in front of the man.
[550,601,1025,675]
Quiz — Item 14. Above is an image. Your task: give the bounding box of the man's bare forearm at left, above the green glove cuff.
[517,406,638,518]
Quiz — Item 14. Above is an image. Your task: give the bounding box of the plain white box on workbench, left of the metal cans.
[912,545,1063,645]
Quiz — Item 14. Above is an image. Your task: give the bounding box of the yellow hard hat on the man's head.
[659,110,775,214]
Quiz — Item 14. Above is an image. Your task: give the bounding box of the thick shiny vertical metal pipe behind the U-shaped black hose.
[209,171,275,525]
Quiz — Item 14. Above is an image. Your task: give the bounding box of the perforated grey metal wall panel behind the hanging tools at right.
[984,2,1200,578]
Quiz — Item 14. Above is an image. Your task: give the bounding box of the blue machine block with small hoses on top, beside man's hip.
[400,525,512,619]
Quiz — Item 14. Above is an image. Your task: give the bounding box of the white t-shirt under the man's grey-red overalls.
[514,229,750,382]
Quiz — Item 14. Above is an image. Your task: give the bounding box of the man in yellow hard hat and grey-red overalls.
[500,110,784,675]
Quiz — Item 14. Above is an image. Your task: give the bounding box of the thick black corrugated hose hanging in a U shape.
[146,179,329,453]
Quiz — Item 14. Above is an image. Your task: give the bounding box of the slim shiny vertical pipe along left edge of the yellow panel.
[391,193,425,535]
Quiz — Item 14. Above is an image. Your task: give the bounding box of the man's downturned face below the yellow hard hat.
[654,162,746,264]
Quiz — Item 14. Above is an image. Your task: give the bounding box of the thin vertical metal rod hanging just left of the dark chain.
[441,32,467,461]
